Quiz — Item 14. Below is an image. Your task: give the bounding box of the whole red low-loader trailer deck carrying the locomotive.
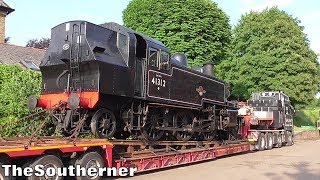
[0,137,252,179]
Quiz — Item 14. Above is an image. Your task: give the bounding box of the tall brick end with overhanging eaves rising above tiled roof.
[0,0,14,43]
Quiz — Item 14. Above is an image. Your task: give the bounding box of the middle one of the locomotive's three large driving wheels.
[175,111,193,141]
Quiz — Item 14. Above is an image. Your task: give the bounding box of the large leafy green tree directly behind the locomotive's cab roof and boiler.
[123,0,231,66]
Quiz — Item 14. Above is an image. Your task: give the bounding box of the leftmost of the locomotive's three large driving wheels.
[141,111,166,141]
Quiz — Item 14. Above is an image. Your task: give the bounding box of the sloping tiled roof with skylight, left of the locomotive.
[0,43,46,66]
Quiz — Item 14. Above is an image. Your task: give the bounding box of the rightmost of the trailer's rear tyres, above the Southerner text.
[75,152,104,180]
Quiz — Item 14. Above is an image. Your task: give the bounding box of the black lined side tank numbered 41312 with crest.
[147,64,226,107]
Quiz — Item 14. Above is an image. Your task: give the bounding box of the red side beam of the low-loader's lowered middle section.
[114,143,251,172]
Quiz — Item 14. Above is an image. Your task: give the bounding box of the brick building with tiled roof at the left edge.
[0,0,46,70]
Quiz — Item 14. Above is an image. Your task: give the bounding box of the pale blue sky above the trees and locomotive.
[4,0,320,54]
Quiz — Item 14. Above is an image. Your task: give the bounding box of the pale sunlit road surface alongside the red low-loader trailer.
[128,140,320,180]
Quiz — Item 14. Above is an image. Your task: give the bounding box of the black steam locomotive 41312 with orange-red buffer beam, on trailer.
[29,21,239,141]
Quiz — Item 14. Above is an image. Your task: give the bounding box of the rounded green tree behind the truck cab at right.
[217,8,319,105]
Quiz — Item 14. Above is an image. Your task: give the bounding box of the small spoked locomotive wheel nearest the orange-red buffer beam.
[91,108,116,138]
